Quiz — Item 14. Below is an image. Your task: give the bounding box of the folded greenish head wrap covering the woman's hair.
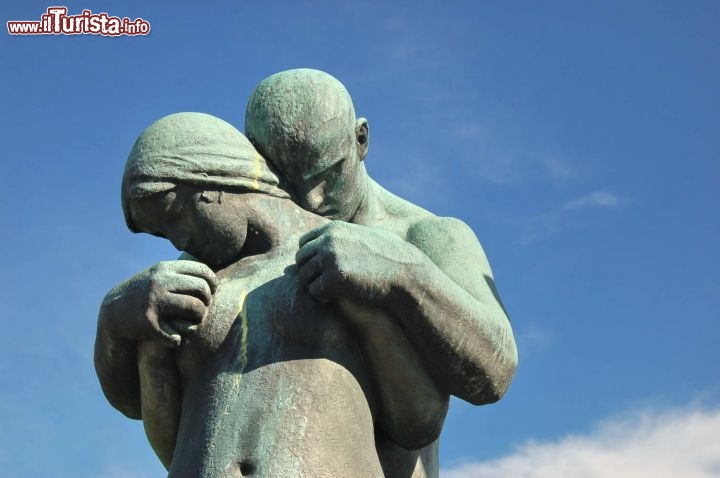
[121,113,289,230]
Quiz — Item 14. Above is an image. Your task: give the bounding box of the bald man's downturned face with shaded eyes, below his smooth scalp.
[278,130,364,221]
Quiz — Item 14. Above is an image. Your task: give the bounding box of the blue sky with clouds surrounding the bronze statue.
[0,0,720,478]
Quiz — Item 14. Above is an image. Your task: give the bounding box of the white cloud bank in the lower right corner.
[440,409,720,478]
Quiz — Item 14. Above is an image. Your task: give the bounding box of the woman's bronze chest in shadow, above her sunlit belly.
[177,261,360,378]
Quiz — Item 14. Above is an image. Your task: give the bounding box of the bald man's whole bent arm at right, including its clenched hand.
[298,217,517,405]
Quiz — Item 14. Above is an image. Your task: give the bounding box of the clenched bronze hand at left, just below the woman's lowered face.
[101,260,218,347]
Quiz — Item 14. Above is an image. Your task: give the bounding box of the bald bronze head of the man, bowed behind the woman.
[245,69,368,221]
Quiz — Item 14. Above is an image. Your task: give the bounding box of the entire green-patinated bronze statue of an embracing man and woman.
[95,70,517,478]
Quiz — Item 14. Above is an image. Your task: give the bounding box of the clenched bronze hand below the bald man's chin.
[295,221,424,306]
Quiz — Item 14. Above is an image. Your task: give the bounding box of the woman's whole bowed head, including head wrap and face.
[122,113,288,266]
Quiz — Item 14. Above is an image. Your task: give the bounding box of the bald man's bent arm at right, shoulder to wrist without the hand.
[402,217,517,405]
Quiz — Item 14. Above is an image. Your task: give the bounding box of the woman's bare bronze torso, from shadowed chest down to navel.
[169,248,383,477]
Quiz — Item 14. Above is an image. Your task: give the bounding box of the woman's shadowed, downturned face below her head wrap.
[130,185,247,268]
